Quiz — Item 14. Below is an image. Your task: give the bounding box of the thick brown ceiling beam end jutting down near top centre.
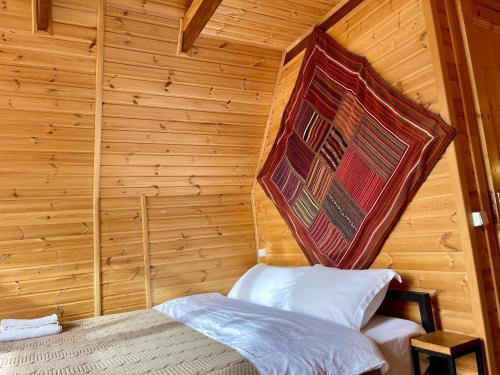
[181,0,222,52]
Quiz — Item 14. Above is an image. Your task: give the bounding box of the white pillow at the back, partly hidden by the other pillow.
[227,264,312,309]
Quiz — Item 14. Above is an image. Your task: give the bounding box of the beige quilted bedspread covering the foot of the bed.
[0,310,258,375]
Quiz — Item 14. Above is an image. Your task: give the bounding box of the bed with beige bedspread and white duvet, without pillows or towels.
[0,266,433,375]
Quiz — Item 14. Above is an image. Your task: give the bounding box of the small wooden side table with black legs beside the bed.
[410,331,485,375]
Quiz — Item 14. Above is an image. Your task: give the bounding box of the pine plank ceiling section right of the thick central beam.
[202,0,340,50]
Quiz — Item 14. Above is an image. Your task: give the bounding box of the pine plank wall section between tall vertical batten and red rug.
[100,0,281,313]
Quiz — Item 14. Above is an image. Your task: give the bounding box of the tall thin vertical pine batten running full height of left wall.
[92,0,106,316]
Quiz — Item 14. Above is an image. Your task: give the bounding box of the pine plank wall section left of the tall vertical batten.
[0,0,96,324]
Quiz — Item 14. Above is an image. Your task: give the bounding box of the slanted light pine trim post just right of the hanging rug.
[422,0,496,374]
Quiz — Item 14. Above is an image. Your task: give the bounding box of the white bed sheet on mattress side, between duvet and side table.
[361,315,425,375]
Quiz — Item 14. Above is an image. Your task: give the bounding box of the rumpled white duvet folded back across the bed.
[155,293,388,375]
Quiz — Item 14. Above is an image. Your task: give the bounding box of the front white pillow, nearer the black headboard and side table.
[284,265,401,331]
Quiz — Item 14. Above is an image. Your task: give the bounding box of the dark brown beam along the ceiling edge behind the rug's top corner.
[283,0,363,65]
